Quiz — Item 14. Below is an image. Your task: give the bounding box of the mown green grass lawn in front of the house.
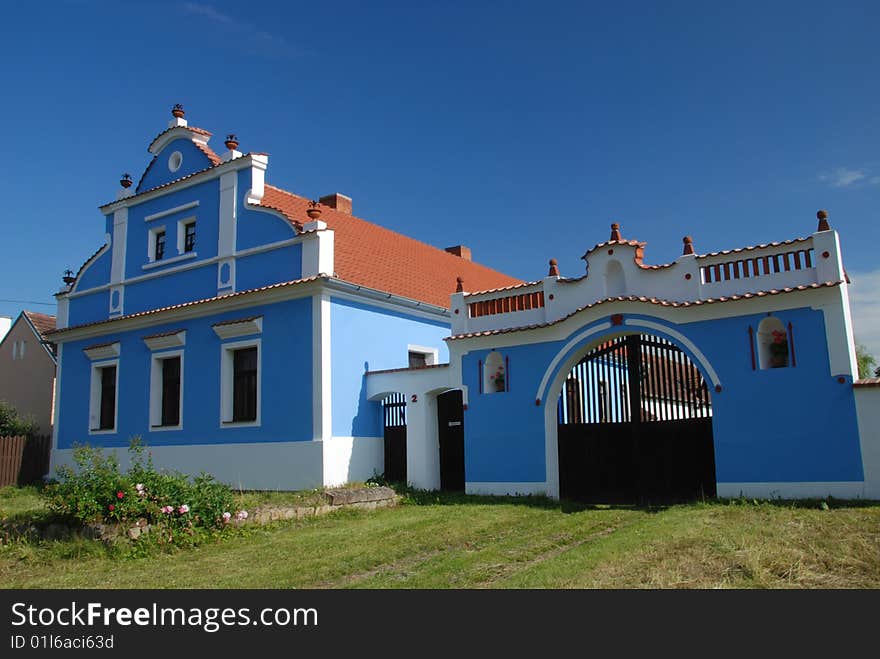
[0,489,880,588]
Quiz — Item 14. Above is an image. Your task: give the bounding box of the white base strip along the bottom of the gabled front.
[52,441,323,492]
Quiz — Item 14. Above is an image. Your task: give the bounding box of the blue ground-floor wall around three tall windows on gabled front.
[58,298,313,449]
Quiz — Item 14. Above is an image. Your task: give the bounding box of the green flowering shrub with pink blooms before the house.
[45,439,240,544]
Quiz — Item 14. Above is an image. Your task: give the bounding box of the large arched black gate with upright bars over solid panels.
[558,334,715,503]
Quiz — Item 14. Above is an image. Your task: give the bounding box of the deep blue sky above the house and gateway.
[0,0,880,356]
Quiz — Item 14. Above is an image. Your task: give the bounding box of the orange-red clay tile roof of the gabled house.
[260,185,522,309]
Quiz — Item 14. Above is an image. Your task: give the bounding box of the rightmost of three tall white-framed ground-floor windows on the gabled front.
[220,339,262,426]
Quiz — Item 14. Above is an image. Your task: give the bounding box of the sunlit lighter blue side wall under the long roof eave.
[330,297,449,437]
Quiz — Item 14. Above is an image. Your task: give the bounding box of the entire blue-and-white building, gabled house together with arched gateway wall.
[51,107,880,501]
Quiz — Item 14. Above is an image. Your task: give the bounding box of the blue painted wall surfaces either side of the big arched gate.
[462,308,863,482]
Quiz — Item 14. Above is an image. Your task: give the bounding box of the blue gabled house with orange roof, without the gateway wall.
[52,106,518,489]
